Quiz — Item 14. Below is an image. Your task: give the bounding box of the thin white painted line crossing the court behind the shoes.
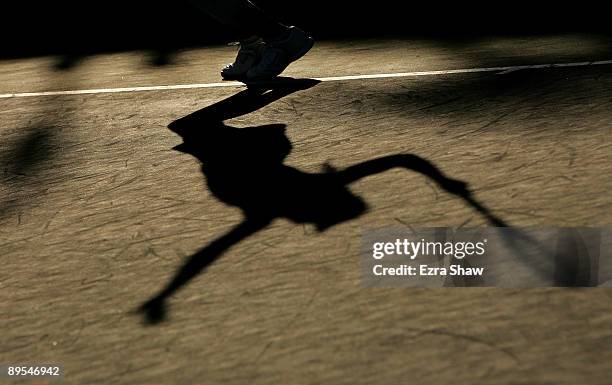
[0,60,612,99]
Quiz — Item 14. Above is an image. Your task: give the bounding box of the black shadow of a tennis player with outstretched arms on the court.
[140,78,505,323]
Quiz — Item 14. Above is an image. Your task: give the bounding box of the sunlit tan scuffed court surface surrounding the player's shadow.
[0,35,612,384]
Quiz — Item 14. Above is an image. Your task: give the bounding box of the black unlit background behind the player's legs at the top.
[0,0,609,59]
